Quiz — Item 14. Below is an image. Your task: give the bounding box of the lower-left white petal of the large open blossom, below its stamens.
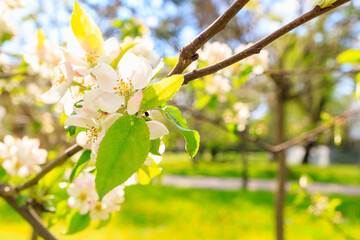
[94,92,125,113]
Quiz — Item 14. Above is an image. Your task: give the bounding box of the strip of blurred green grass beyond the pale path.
[161,152,360,185]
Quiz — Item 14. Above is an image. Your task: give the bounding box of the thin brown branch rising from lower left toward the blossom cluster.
[0,144,82,195]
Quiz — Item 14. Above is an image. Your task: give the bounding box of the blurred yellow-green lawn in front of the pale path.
[0,186,360,240]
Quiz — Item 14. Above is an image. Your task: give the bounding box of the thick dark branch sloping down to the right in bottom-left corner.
[0,182,56,240]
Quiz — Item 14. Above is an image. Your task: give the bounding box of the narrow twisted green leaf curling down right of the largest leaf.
[164,106,200,158]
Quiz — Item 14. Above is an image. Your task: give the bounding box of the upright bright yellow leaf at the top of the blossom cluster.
[71,1,105,56]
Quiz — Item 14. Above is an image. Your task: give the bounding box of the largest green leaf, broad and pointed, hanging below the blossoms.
[95,115,150,199]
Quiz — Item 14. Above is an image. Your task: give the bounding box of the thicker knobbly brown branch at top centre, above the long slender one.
[169,0,249,76]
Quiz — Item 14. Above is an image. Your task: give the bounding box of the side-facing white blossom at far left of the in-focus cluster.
[40,62,73,104]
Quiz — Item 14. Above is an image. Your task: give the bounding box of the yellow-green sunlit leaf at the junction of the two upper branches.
[140,75,184,110]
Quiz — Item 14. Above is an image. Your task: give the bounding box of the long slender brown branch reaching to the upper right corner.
[179,0,350,84]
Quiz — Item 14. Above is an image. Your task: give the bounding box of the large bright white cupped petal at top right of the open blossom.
[118,52,152,90]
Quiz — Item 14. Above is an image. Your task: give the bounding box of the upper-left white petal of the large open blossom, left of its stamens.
[93,63,118,92]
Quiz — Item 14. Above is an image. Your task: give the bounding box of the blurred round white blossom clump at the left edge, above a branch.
[0,135,47,177]
